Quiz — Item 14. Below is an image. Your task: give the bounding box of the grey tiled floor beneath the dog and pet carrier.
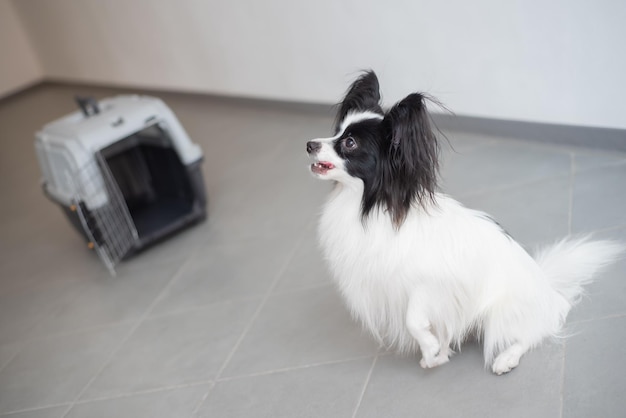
[0,85,626,418]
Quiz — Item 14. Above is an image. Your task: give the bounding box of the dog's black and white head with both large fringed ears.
[307,71,439,228]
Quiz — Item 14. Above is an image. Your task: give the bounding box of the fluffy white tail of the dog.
[535,236,626,306]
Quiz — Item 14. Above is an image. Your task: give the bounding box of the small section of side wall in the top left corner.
[0,0,42,98]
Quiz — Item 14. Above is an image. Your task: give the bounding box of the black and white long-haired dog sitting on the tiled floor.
[306,71,624,375]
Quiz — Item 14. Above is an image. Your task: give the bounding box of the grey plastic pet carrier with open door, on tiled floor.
[35,96,206,275]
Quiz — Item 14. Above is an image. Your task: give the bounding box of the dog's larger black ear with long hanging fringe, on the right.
[382,93,439,228]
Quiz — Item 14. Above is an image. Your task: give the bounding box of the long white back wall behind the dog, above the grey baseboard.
[9,0,626,128]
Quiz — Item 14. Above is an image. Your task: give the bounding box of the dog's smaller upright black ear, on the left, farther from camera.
[335,70,383,132]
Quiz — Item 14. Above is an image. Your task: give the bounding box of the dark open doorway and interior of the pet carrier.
[100,125,204,247]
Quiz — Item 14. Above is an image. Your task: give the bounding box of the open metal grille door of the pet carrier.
[72,153,138,276]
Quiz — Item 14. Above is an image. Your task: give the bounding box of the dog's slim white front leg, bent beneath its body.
[406,295,450,369]
